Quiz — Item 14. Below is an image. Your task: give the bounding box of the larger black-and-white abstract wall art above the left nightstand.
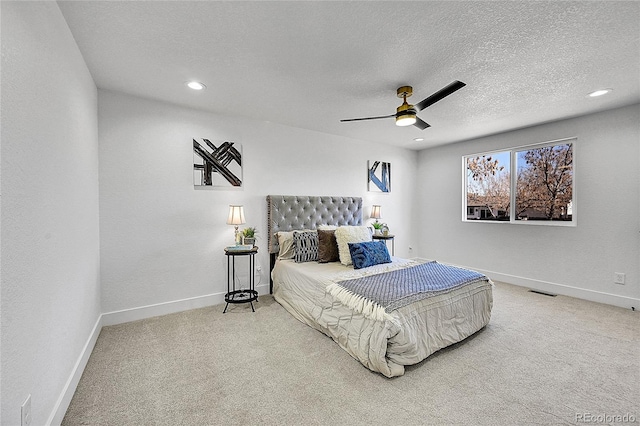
[193,139,242,188]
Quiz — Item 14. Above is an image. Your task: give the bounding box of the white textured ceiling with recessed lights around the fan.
[58,1,640,149]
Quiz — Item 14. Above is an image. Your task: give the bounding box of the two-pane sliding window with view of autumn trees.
[463,139,576,225]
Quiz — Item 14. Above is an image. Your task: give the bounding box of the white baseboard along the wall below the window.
[415,257,640,310]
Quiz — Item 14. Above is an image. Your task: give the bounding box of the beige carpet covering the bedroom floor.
[63,283,640,425]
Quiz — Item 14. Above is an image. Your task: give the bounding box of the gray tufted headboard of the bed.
[267,195,362,253]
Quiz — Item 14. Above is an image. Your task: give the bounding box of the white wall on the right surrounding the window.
[418,104,640,309]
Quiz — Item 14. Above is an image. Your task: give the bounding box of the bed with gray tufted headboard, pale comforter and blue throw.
[267,195,493,377]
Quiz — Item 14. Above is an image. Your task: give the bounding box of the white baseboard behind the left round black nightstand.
[102,284,269,326]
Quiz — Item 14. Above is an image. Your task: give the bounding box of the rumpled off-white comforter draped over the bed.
[272,257,493,377]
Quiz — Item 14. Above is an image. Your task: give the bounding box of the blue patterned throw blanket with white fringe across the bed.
[332,262,489,312]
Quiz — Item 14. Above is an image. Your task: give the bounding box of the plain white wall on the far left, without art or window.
[0,1,100,425]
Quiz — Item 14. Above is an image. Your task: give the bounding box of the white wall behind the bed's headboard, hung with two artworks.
[98,89,417,316]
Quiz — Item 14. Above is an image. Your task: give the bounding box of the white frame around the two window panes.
[462,137,578,227]
